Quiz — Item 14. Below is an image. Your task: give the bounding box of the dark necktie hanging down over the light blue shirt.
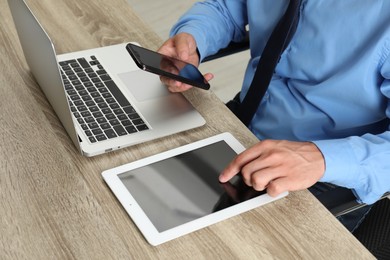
[237,0,301,126]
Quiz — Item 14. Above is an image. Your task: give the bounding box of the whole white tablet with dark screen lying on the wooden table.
[102,133,287,245]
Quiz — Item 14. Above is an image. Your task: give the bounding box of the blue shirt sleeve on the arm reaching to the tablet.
[313,51,390,204]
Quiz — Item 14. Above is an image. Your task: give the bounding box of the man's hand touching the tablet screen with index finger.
[219,140,325,196]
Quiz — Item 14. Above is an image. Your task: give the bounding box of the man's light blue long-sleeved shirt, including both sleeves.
[171,0,390,204]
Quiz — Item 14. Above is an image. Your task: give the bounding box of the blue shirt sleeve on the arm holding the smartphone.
[170,0,248,59]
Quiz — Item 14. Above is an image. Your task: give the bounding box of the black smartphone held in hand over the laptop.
[126,43,210,89]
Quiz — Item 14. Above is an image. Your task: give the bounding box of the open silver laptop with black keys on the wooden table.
[8,0,205,156]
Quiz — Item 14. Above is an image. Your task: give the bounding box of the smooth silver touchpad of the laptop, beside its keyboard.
[118,70,170,102]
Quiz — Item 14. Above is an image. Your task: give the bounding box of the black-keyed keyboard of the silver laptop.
[59,56,149,143]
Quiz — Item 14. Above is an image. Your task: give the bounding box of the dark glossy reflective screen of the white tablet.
[118,141,265,232]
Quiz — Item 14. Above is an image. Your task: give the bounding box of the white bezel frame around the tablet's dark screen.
[102,133,288,246]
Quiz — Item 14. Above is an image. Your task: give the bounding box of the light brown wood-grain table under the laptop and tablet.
[0,0,372,259]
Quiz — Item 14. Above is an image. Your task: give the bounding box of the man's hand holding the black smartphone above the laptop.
[158,33,214,92]
